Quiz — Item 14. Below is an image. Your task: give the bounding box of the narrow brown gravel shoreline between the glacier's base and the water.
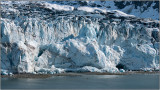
[1,71,160,78]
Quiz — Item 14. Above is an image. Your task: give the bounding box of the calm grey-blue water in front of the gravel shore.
[1,74,159,89]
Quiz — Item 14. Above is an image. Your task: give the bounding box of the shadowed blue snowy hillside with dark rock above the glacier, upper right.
[50,0,159,20]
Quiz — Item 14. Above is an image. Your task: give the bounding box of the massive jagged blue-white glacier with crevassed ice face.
[1,2,160,74]
